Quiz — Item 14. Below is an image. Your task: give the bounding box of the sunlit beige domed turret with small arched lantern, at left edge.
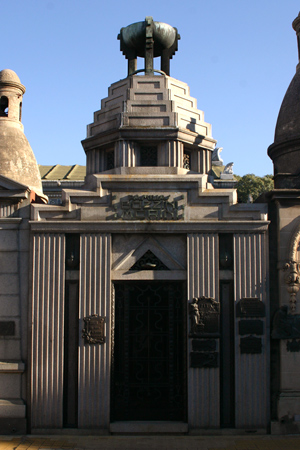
[0,69,45,198]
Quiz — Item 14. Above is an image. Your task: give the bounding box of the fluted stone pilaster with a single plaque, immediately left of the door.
[78,234,111,429]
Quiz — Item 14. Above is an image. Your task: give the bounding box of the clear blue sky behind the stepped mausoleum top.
[0,0,300,176]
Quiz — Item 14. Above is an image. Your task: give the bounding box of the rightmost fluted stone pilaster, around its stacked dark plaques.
[234,234,269,428]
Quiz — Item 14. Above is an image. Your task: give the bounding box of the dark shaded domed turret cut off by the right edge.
[268,13,300,189]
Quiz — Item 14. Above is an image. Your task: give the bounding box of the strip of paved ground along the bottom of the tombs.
[0,436,300,450]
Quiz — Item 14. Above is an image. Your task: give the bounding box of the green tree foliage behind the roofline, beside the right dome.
[235,173,274,203]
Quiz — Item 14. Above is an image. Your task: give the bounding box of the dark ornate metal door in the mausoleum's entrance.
[111,281,186,421]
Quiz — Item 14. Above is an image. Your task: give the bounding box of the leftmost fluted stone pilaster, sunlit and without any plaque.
[31,234,65,428]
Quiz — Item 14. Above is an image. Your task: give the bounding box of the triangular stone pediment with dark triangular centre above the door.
[113,236,185,271]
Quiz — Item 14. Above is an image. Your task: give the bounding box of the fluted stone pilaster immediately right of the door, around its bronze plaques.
[187,234,220,428]
